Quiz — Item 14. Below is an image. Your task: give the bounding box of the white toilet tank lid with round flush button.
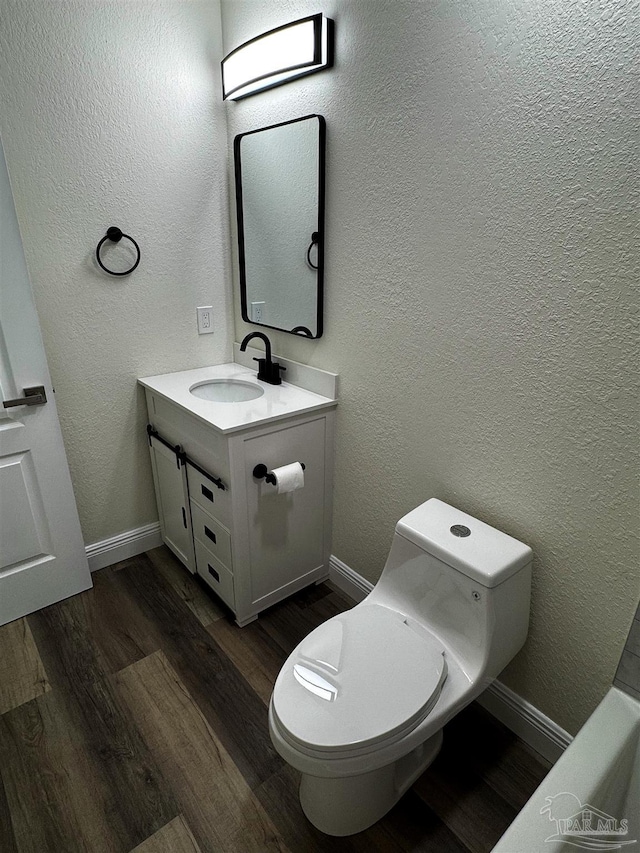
[396,498,533,588]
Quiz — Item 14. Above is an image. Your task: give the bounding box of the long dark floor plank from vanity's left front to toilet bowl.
[113,556,280,788]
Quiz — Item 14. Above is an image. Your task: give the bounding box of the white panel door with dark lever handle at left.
[0,136,92,625]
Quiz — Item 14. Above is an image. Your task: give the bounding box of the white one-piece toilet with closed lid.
[269,498,532,835]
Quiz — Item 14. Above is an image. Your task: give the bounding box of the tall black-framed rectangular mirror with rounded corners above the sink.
[234,114,326,338]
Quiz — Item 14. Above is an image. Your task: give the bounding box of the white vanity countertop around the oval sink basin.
[138,363,337,433]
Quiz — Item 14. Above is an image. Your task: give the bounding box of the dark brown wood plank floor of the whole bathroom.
[0,548,548,853]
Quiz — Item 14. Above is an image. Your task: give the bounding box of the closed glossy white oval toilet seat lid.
[272,604,447,752]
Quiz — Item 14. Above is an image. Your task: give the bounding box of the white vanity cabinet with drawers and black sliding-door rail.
[141,366,336,626]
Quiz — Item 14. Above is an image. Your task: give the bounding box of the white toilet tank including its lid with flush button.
[367,498,533,682]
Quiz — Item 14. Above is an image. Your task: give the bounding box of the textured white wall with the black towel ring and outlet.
[0,0,231,542]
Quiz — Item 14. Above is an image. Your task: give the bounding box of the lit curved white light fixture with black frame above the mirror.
[222,13,333,101]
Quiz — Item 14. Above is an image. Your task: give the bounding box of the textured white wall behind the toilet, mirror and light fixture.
[222,0,640,731]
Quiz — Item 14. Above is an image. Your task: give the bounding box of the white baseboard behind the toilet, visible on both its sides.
[329,555,572,763]
